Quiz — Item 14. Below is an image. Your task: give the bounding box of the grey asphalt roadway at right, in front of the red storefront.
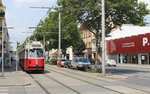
[106,67,150,92]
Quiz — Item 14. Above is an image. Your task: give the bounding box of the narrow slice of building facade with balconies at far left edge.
[0,0,10,67]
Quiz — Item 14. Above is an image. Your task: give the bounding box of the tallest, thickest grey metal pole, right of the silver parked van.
[102,0,105,76]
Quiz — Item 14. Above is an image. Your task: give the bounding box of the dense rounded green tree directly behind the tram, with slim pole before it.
[31,11,85,54]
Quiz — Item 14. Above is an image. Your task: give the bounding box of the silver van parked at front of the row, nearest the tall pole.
[71,57,91,69]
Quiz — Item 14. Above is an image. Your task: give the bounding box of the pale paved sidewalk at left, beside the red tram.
[0,64,31,86]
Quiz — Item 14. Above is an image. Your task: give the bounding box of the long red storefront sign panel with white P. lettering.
[106,33,150,54]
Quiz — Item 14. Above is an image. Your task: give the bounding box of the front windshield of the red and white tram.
[29,49,44,58]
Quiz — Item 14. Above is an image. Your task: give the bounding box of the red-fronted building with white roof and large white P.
[106,26,150,65]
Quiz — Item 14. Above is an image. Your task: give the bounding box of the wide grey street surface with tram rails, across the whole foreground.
[0,65,150,94]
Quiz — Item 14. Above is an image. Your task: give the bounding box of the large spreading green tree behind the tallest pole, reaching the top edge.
[58,0,149,64]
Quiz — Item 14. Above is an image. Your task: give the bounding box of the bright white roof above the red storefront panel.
[106,25,150,40]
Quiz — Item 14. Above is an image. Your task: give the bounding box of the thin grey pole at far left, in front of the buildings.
[2,19,4,77]
